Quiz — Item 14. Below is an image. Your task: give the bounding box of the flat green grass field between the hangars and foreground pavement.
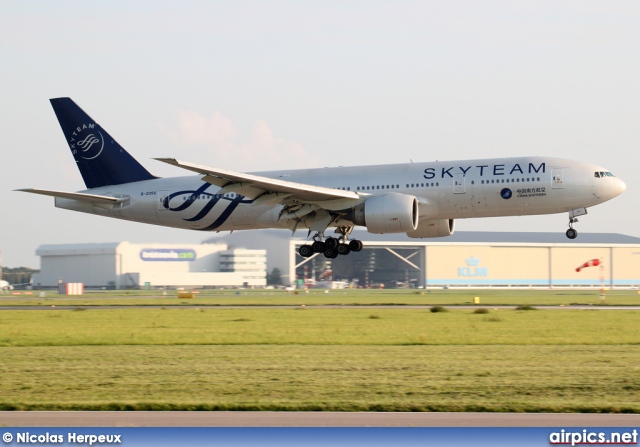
[0,291,640,413]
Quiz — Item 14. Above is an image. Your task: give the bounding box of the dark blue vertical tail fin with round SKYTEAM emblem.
[50,98,156,189]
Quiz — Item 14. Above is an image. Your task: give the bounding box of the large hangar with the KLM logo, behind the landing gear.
[220,230,640,288]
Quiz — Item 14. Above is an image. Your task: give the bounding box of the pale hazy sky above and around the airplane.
[0,0,640,268]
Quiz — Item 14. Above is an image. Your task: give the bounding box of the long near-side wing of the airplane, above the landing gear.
[156,158,360,201]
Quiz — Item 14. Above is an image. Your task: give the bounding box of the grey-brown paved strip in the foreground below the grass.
[0,411,640,427]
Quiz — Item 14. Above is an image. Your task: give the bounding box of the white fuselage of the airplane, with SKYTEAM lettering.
[56,157,625,236]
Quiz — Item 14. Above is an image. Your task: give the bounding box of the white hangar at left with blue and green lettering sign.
[33,242,267,289]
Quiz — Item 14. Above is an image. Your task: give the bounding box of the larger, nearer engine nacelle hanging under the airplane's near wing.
[352,193,418,234]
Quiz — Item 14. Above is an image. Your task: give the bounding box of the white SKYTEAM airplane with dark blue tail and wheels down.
[17,98,626,259]
